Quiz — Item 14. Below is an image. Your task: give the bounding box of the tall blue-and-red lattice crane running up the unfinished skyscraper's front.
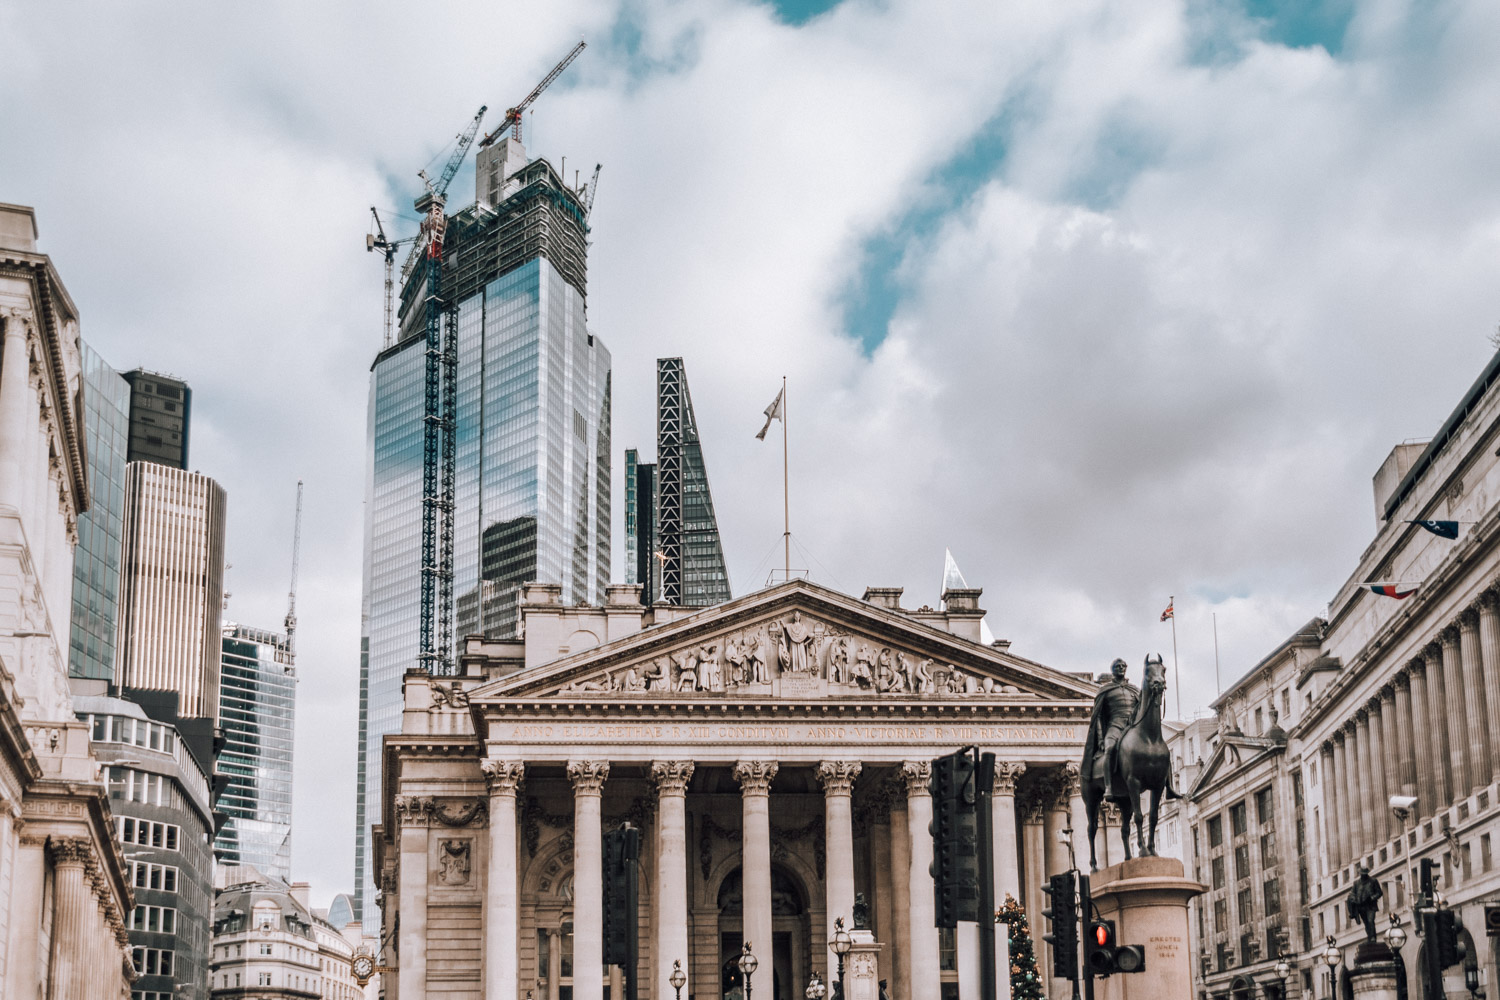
[416,108,486,675]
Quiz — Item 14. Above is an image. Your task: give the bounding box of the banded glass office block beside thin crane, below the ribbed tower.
[213,624,297,879]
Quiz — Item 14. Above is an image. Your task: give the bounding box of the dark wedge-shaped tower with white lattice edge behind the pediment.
[626,358,729,607]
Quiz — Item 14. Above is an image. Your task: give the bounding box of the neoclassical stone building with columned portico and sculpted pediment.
[374,580,1095,1000]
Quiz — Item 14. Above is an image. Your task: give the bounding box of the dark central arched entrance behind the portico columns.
[719,864,812,1000]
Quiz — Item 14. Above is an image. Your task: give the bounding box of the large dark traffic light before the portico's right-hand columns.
[929,753,980,927]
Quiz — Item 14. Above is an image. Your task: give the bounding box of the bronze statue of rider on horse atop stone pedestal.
[1079,654,1181,871]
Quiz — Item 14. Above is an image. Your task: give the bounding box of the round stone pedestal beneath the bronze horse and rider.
[1082,858,1208,1000]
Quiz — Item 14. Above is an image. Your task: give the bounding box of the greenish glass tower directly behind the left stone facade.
[68,343,131,681]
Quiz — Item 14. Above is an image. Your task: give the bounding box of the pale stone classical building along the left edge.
[0,205,132,1000]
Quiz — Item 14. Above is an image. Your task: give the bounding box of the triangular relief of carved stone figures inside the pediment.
[561,610,1020,696]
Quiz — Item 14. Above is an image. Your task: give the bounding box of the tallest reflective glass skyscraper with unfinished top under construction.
[356,146,611,927]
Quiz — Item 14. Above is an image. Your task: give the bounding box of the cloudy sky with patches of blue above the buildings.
[0,0,1500,904]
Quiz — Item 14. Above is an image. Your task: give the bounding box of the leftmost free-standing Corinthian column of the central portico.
[480,759,527,1000]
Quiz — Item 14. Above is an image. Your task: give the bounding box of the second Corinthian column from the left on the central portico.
[567,760,609,1000]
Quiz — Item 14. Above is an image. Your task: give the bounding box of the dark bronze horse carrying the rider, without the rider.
[1082,654,1178,871]
